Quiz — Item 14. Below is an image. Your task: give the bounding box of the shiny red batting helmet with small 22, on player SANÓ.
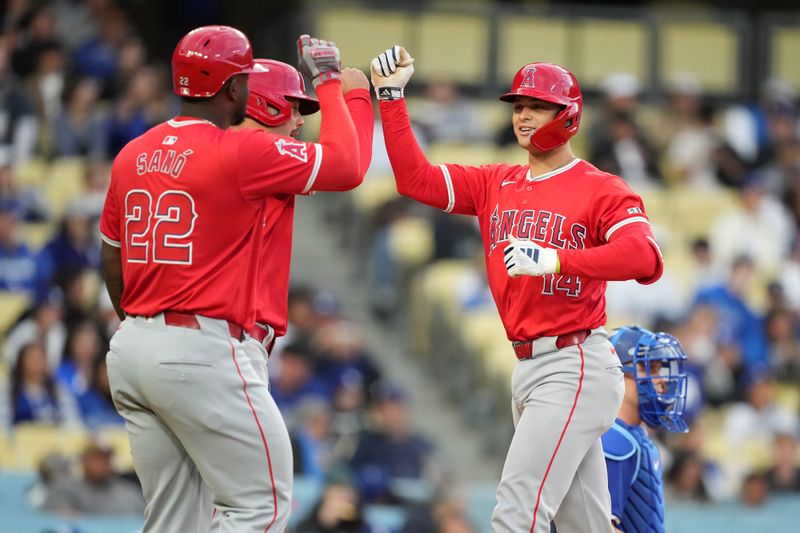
[172,26,253,97]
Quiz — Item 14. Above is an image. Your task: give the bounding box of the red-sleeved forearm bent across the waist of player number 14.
[558,233,664,283]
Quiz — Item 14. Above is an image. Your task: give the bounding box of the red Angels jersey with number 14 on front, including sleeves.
[381,101,663,340]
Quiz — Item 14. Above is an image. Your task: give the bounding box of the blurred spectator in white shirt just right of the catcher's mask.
[725,370,798,451]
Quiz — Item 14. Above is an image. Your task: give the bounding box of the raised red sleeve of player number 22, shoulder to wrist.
[238,80,363,201]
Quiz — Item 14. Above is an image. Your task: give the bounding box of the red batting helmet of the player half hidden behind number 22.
[247,59,319,126]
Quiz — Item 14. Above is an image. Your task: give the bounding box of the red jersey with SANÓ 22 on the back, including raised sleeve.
[100,82,361,328]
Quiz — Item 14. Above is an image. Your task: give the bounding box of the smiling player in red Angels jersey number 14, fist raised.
[372,46,663,533]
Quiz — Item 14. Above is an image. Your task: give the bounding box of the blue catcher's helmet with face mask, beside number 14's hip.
[608,326,689,432]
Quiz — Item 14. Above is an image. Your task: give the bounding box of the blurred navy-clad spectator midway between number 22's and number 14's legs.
[350,383,433,492]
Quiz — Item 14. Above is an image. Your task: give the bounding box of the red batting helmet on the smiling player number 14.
[500,63,583,151]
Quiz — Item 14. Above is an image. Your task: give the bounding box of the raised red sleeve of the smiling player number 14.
[380,99,487,215]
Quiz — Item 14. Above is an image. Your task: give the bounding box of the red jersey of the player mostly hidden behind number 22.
[256,89,374,337]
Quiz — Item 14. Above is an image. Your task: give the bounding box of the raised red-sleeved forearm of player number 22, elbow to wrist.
[314,80,364,191]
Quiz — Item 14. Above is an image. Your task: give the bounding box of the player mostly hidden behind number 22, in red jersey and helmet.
[241,59,373,381]
